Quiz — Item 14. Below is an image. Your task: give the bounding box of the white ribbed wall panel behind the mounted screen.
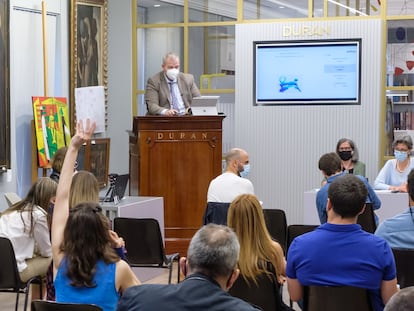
[234,19,383,223]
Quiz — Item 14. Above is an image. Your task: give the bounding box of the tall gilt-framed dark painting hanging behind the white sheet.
[70,0,108,128]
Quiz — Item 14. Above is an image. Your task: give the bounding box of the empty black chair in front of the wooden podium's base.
[114,217,180,284]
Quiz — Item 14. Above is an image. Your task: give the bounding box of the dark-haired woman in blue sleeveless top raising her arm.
[52,120,139,311]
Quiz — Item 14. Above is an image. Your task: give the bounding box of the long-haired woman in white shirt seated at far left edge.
[0,177,57,282]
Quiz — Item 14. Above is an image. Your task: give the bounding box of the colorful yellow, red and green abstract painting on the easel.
[32,96,71,168]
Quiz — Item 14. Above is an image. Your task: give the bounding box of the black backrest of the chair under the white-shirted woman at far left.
[0,237,21,290]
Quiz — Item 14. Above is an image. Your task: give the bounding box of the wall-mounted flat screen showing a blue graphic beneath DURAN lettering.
[253,39,361,105]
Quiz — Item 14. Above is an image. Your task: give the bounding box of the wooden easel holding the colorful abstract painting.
[30,1,50,183]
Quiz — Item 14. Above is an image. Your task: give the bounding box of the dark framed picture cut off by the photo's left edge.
[0,0,10,173]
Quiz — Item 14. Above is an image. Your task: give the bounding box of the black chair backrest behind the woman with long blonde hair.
[229,273,281,311]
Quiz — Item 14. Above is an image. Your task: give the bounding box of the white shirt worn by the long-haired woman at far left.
[0,206,52,272]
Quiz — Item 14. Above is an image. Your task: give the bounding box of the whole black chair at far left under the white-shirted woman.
[0,237,43,311]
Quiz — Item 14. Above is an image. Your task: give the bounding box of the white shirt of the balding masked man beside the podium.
[207,172,254,203]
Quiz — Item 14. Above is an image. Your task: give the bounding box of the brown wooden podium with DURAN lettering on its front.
[129,116,224,256]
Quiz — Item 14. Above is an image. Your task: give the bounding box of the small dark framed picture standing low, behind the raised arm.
[77,138,111,188]
